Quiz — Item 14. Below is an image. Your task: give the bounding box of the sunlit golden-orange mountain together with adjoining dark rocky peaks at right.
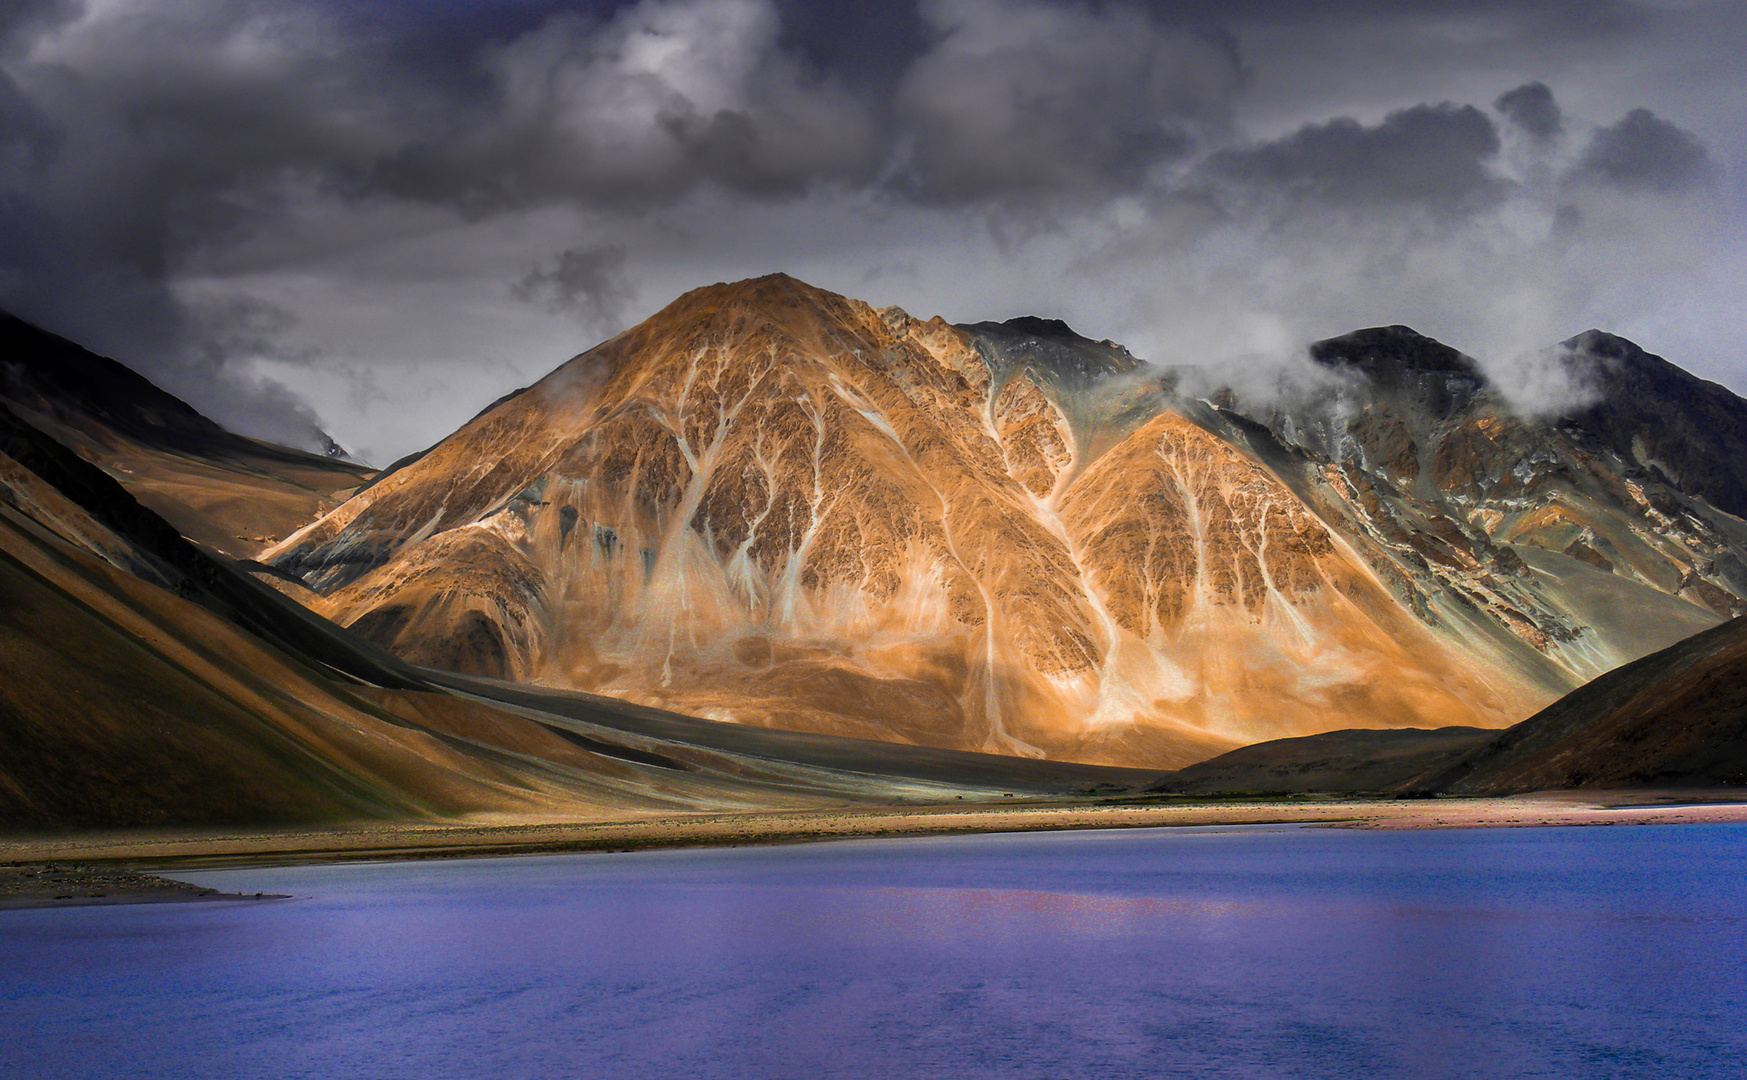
[260,274,1747,769]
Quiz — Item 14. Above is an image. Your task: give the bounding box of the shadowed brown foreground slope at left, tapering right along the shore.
[0,347,1157,834]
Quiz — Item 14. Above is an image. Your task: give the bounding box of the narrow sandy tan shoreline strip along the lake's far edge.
[0,790,1747,870]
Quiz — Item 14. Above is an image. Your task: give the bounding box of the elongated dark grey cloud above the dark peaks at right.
[1205,103,1499,213]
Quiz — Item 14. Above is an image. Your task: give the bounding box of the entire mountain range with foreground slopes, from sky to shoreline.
[0,274,1747,827]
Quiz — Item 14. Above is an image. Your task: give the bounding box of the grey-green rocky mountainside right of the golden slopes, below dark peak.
[1187,327,1747,696]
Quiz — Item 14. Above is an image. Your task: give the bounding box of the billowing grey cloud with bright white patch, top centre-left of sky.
[370,0,882,213]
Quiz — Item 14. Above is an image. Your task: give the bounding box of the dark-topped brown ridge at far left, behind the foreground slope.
[0,313,372,557]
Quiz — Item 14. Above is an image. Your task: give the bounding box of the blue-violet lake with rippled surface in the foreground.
[0,825,1747,1080]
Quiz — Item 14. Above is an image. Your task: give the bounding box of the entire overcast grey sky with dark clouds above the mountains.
[0,0,1747,465]
